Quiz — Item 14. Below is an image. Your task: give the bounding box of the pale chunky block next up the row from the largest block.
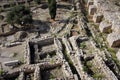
[99,20,112,33]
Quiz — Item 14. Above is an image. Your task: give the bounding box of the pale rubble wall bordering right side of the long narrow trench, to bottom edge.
[69,36,94,80]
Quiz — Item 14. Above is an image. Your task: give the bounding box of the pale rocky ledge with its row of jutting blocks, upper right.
[87,0,120,47]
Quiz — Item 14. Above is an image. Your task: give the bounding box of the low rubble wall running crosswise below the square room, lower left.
[4,61,62,78]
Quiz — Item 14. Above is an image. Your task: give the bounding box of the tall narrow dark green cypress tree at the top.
[48,0,57,20]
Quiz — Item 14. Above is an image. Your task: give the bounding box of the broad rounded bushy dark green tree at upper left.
[6,5,33,25]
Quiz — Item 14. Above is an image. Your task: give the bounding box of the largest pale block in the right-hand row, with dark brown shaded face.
[107,32,120,47]
